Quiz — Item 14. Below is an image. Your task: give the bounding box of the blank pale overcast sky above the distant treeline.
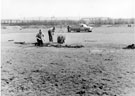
[1,0,135,19]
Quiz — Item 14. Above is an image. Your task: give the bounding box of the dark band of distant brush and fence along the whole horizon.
[1,18,135,26]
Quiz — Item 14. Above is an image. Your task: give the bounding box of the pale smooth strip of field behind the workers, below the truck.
[2,26,135,44]
